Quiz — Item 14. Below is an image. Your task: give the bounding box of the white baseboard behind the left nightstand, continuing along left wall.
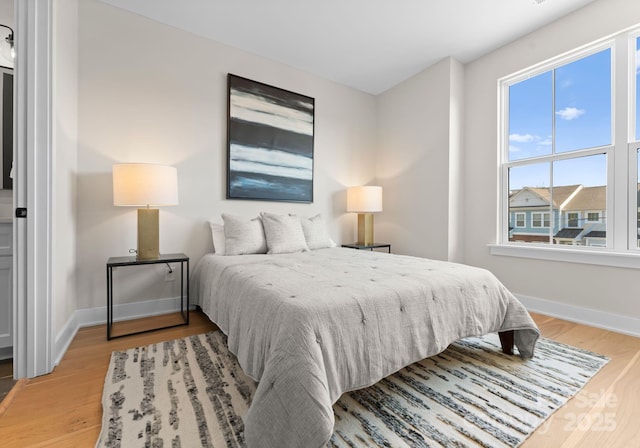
[54,297,195,366]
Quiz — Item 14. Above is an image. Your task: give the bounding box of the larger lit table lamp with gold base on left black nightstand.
[113,163,178,260]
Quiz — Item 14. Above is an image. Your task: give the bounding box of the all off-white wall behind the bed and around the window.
[70,0,640,332]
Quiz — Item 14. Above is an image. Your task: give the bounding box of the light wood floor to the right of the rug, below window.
[521,314,640,448]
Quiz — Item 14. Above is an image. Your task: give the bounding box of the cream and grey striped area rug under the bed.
[96,332,608,448]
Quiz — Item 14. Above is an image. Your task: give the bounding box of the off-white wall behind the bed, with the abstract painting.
[77,0,376,309]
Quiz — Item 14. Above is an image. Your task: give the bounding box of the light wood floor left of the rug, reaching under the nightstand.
[0,312,216,448]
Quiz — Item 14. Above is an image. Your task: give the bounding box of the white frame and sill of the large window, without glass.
[496,26,640,269]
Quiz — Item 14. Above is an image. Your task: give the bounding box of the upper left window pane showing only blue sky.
[509,71,553,164]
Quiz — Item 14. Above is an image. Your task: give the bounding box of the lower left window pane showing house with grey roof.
[509,163,551,244]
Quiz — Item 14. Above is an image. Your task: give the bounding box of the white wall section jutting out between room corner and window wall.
[376,58,464,261]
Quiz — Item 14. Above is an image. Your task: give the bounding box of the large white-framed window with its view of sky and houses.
[499,29,640,260]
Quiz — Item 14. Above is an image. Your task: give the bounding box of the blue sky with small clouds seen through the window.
[509,48,612,190]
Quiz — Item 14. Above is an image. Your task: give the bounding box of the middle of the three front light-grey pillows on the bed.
[260,212,309,254]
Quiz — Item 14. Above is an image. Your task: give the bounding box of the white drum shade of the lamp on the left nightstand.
[113,163,178,207]
